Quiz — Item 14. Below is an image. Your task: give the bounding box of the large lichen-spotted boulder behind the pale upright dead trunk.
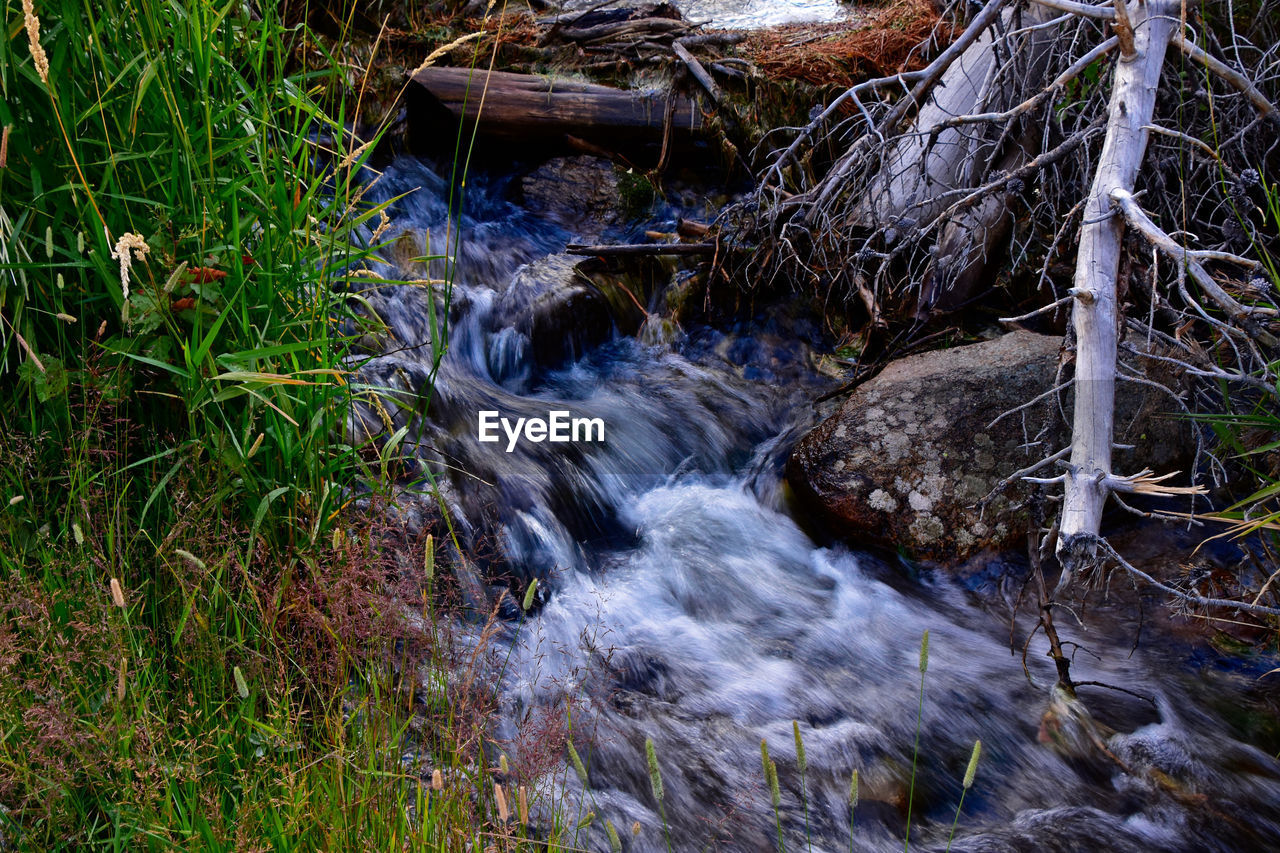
[787,332,1190,564]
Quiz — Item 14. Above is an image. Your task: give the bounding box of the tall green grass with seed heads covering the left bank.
[0,0,519,850]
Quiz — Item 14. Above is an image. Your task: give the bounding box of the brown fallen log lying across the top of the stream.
[408,68,703,142]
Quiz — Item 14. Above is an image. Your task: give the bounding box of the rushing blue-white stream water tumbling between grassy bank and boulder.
[358,158,1280,850]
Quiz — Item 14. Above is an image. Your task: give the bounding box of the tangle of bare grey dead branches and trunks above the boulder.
[723,0,1280,625]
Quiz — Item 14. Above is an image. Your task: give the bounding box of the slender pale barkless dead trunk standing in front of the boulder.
[1055,0,1178,573]
